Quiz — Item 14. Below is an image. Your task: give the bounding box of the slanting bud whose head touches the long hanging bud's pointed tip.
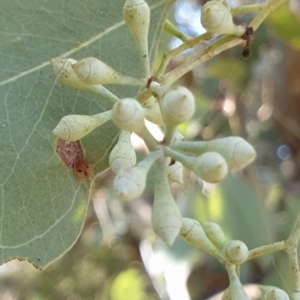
[180,218,224,262]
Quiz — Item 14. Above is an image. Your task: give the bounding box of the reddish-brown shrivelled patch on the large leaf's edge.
[55,139,93,181]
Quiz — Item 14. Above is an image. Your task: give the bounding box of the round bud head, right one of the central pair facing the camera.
[160,86,195,126]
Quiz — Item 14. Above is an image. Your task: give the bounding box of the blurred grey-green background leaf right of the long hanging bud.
[218,176,276,249]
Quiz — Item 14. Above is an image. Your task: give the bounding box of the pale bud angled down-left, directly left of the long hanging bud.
[114,151,162,201]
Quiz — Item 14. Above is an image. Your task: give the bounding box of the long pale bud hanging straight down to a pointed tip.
[151,163,182,246]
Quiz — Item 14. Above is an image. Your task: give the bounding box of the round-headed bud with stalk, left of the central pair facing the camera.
[112,98,159,150]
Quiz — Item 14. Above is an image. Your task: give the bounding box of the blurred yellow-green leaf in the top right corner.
[267,4,300,50]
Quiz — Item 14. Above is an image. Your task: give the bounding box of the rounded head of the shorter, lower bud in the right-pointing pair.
[192,152,228,183]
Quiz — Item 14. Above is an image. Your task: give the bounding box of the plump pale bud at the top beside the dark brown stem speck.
[201,0,246,36]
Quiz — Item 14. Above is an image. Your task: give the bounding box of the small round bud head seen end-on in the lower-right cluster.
[222,240,249,265]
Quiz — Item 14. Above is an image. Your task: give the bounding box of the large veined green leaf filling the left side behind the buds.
[0,0,170,268]
